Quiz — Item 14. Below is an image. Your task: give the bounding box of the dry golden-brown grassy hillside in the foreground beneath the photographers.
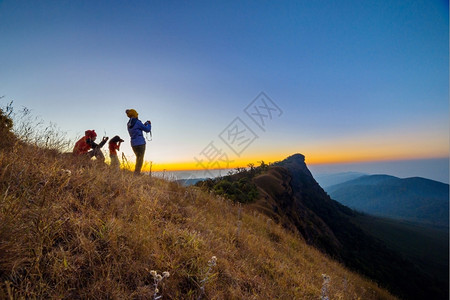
[0,111,394,299]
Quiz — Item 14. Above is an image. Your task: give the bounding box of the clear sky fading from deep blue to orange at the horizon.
[0,0,449,181]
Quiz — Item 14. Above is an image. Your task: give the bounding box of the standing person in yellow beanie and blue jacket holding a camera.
[125,109,152,174]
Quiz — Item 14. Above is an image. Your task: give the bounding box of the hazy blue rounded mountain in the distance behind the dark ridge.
[325,175,449,227]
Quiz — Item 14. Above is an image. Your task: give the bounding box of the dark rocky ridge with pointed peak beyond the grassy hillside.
[197,154,448,299]
